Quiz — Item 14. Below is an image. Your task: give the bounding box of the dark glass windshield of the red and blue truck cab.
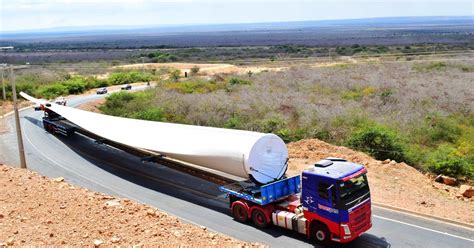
[339,174,369,205]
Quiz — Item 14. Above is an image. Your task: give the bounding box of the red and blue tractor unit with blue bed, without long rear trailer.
[220,158,372,244]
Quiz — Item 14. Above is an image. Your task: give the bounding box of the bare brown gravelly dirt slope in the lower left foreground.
[0,165,263,247]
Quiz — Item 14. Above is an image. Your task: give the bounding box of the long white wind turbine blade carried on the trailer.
[20,92,288,183]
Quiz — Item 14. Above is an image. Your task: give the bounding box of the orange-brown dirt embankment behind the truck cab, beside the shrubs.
[288,139,474,224]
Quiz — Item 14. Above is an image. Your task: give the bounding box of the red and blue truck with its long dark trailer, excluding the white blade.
[35,104,372,245]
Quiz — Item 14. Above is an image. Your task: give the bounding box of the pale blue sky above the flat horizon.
[0,0,474,31]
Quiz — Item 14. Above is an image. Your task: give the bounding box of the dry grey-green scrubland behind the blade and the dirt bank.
[101,60,474,180]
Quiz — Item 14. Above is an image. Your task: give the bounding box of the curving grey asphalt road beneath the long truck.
[0,92,474,247]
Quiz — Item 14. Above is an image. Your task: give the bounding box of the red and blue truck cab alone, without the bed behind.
[301,158,372,243]
